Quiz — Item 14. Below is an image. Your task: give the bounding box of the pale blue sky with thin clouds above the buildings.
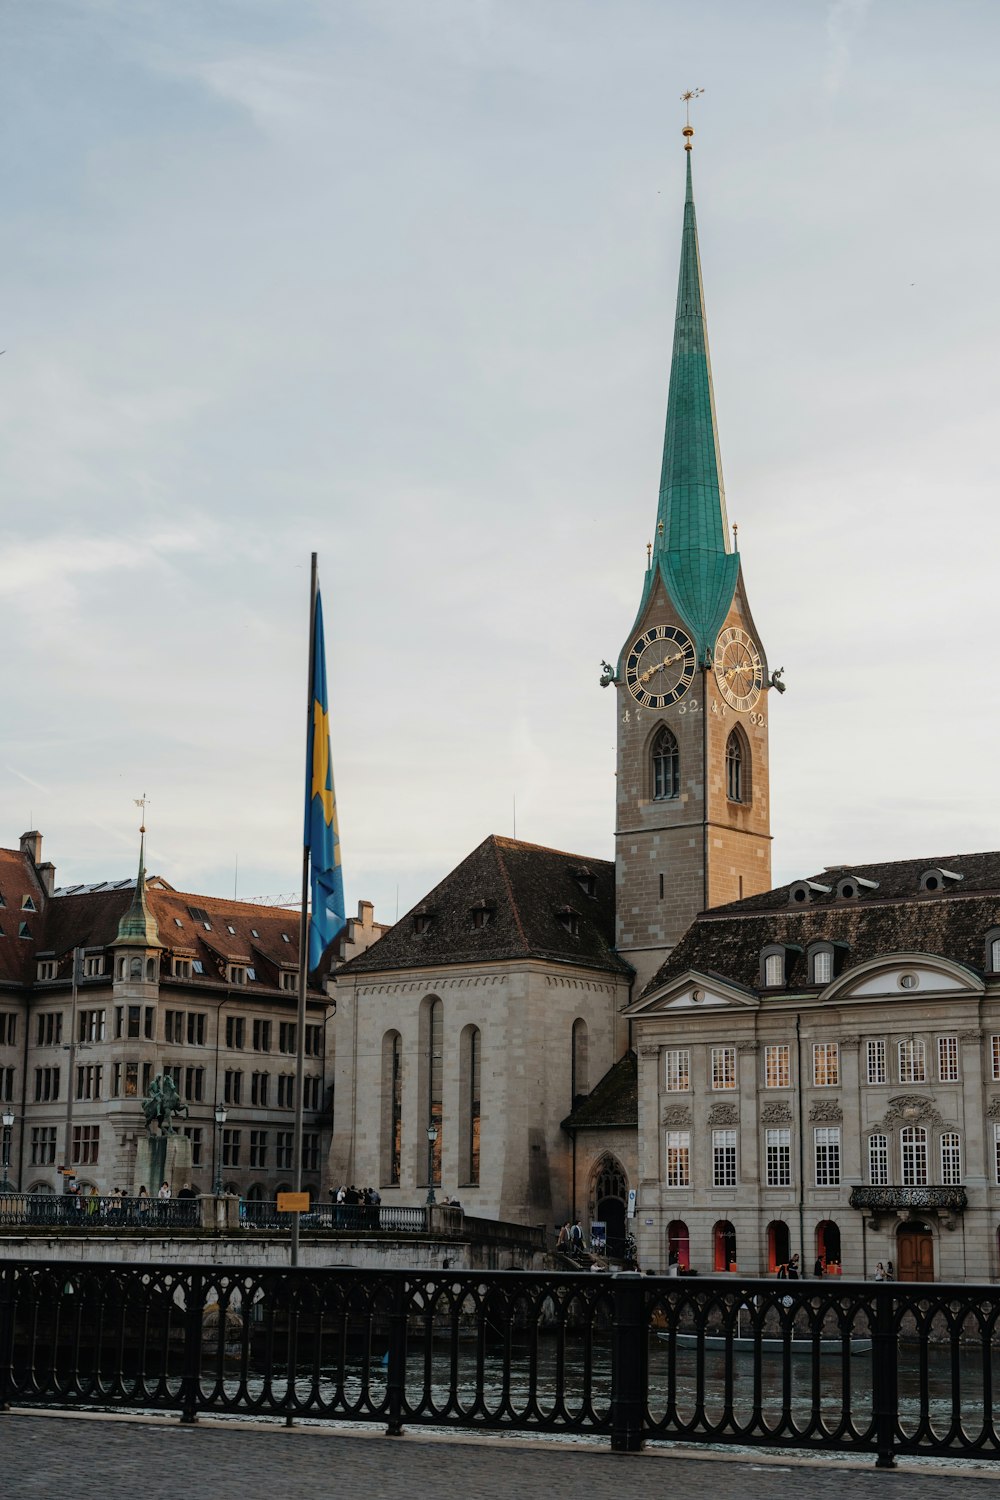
[0,0,1000,920]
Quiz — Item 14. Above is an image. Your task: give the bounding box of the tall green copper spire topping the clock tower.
[640,143,739,660]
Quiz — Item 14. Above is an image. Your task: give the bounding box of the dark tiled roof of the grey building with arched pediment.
[643,854,1000,995]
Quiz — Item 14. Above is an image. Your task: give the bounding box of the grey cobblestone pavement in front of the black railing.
[0,1412,1000,1500]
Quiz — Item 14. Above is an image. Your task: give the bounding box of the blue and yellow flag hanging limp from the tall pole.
[306,590,346,974]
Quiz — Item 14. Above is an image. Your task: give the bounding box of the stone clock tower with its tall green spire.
[607,125,783,987]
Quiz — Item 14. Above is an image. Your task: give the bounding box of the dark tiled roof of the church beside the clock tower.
[337,834,631,974]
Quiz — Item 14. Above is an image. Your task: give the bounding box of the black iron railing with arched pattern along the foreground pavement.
[0,1262,1000,1467]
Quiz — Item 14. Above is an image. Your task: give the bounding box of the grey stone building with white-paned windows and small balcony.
[630,855,1000,1281]
